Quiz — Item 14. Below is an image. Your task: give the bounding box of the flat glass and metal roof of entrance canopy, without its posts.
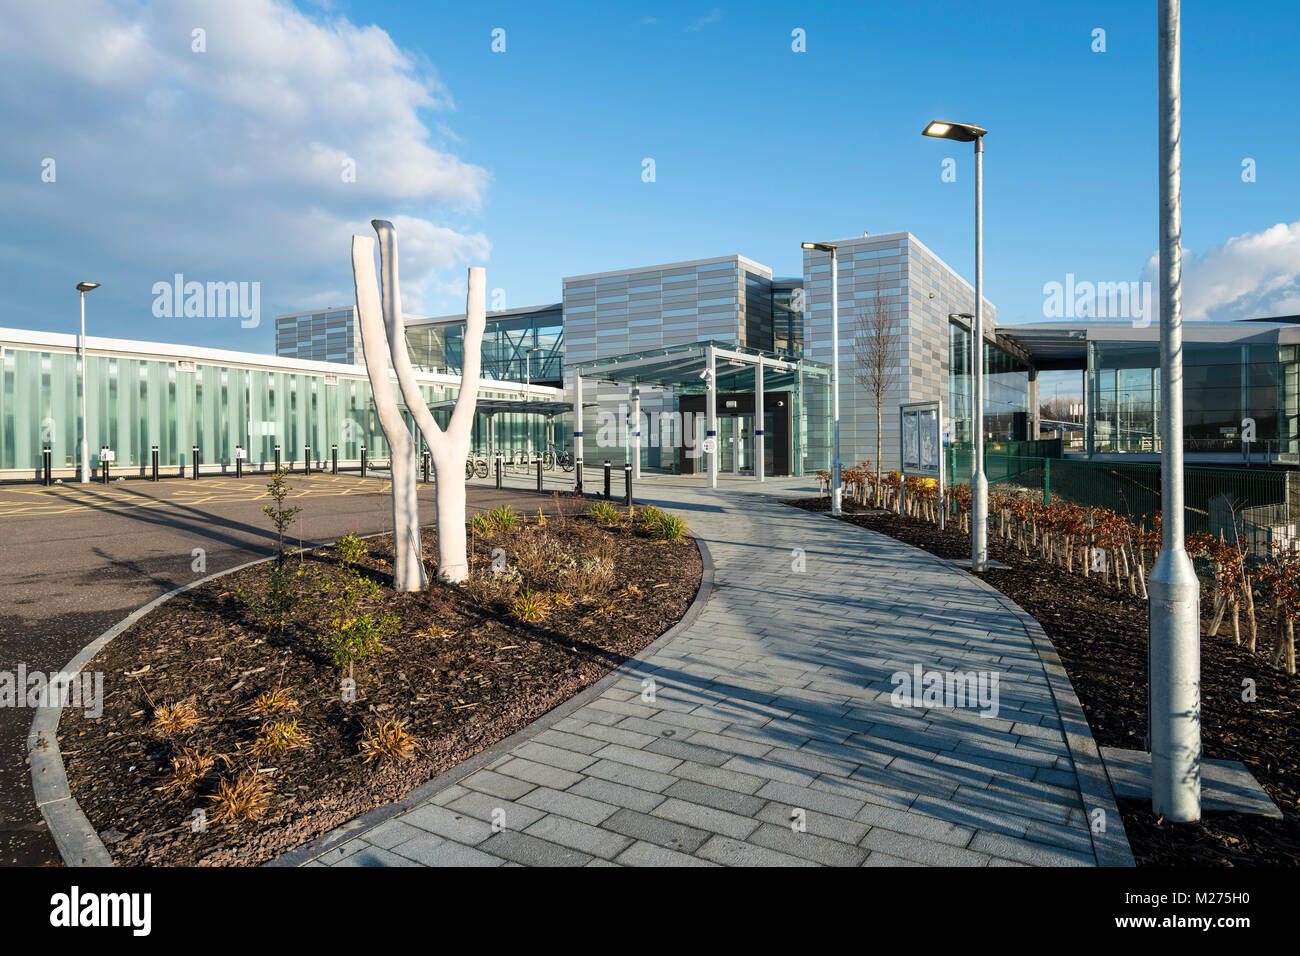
[569,339,831,392]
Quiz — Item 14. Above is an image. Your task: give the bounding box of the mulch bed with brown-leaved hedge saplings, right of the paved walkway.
[787,498,1300,866]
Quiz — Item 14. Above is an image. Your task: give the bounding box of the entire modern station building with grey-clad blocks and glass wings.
[0,233,1300,477]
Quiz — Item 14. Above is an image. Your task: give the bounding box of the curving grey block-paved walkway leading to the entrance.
[299,479,1122,866]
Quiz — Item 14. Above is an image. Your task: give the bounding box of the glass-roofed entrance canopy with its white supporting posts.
[569,339,831,489]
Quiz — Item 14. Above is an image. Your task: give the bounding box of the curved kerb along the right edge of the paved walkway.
[789,506,1136,866]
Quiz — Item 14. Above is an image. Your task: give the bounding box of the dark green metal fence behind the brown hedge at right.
[948,446,1300,549]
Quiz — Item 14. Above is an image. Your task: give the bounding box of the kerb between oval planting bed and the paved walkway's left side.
[263,537,714,866]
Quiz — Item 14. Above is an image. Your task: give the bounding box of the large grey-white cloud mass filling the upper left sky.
[0,0,490,347]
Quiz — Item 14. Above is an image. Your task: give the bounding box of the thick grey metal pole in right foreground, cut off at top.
[1147,0,1201,822]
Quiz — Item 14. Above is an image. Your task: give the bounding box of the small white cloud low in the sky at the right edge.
[1143,221,1300,321]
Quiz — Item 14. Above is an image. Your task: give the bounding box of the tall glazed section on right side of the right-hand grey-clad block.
[948,321,1037,445]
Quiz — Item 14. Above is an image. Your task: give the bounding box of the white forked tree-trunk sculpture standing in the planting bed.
[352,220,488,591]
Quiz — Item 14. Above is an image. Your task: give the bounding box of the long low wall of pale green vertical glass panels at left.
[0,339,553,475]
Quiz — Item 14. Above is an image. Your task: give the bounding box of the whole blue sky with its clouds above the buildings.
[0,0,1300,351]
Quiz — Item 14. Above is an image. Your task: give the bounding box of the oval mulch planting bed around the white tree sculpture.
[59,498,702,866]
